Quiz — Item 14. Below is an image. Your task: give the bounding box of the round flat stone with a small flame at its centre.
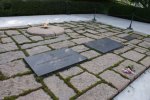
[27,26,65,36]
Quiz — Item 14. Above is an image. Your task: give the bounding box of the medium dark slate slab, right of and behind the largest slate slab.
[85,38,123,53]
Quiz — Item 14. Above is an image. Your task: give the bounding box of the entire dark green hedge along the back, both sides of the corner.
[0,0,150,22]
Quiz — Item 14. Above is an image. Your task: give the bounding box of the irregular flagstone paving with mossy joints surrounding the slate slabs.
[0,22,150,100]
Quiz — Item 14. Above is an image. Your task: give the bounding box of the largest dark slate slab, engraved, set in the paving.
[25,48,87,76]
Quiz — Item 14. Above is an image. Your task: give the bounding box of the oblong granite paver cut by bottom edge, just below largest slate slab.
[44,75,75,100]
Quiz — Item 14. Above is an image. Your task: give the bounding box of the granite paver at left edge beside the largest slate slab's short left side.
[0,60,29,77]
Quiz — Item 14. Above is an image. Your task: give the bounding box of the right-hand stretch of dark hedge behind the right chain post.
[109,4,150,23]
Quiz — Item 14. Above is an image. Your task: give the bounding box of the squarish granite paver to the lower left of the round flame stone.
[13,35,31,44]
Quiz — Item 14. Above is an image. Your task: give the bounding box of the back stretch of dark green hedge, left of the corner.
[0,0,111,16]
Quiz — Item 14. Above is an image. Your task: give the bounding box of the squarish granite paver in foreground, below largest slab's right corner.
[70,72,100,91]
